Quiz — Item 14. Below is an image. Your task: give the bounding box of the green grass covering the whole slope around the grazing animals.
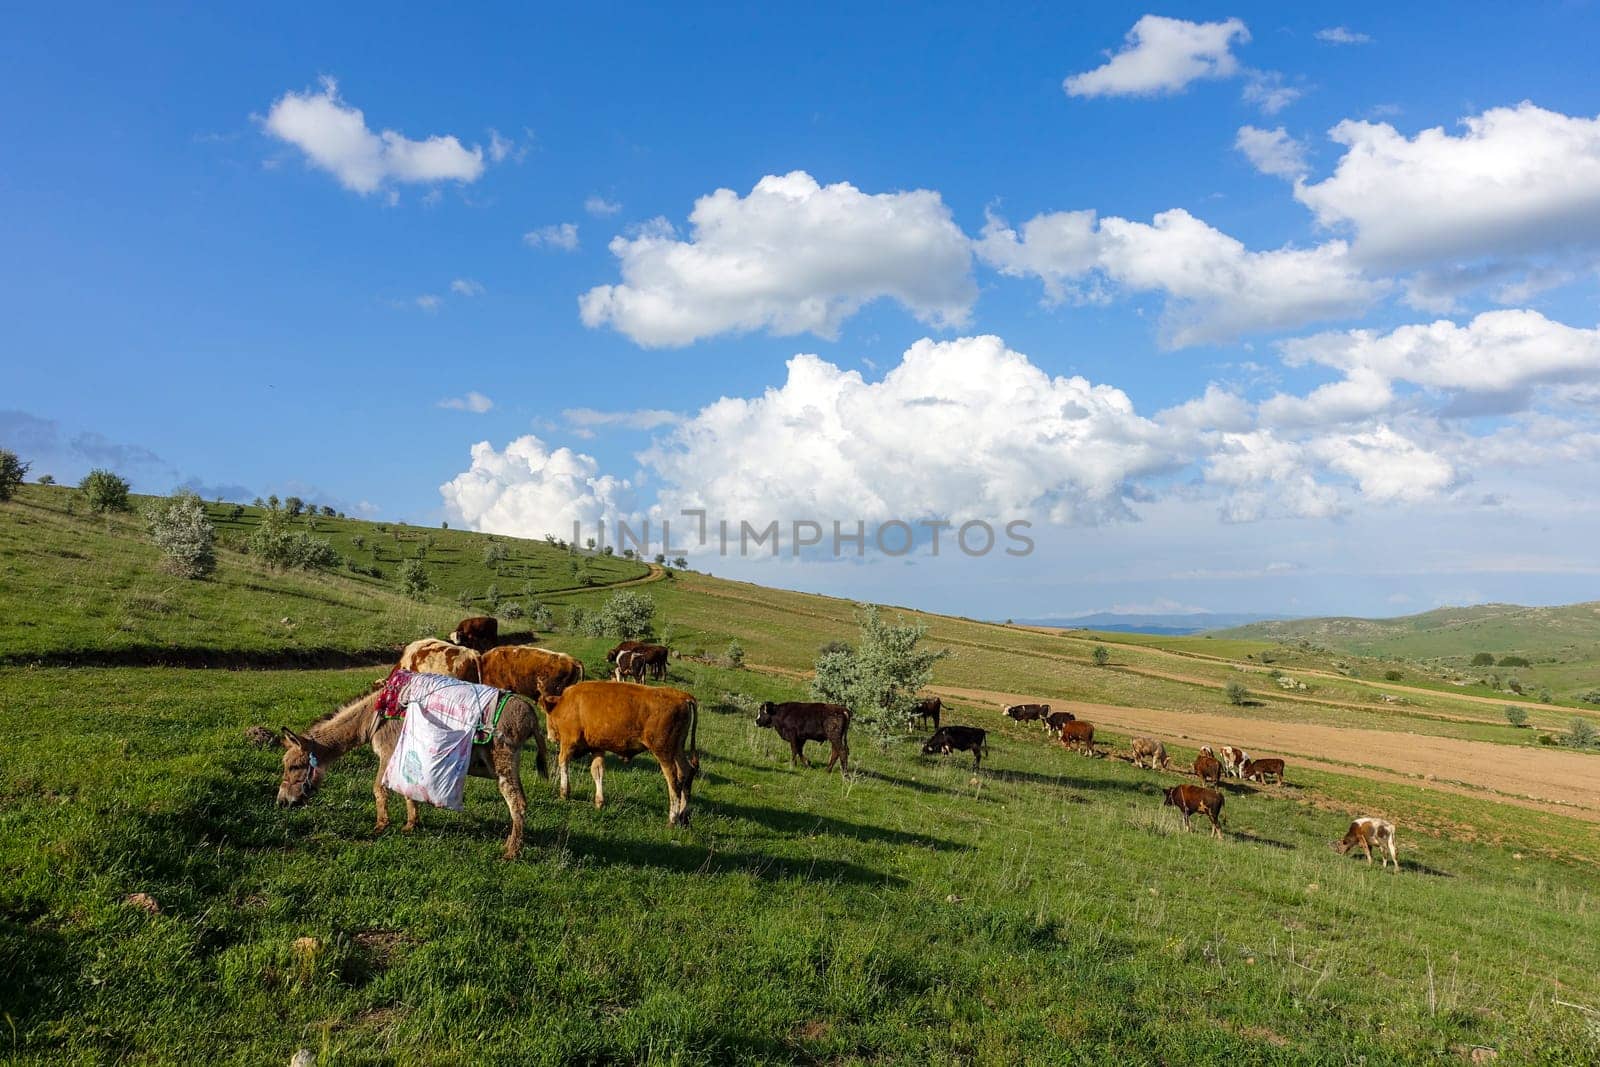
[0,486,1600,1064]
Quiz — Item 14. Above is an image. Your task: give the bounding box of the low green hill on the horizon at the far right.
[1218,601,1600,662]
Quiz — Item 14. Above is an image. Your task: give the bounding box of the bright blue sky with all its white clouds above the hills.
[0,3,1600,617]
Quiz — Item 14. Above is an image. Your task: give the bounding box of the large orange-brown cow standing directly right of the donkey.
[539,681,699,825]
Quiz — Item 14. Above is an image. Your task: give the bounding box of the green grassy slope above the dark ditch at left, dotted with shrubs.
[0,486,648,664]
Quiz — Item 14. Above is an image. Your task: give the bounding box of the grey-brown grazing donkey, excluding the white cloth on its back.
[278,693,550,859]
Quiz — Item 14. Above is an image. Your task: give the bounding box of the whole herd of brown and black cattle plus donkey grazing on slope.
[278,617,1400,870]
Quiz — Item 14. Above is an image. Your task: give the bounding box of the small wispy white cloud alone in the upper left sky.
[262,77,483,195]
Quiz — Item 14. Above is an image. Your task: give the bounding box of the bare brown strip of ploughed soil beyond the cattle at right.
[928,686,1600,822]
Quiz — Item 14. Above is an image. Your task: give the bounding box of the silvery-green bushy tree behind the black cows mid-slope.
[811,605,950,741]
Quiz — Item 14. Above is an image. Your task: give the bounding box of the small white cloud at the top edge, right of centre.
[1062,14,1250,96]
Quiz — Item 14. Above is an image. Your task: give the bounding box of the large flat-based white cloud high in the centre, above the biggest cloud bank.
[579,171,976,347]
